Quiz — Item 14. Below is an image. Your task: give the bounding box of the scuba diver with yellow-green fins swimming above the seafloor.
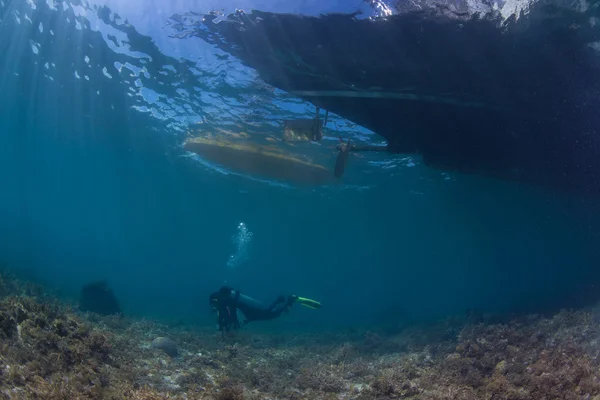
[208,286,321,334]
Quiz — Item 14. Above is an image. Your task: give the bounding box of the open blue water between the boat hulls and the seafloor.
[0,1,600,329]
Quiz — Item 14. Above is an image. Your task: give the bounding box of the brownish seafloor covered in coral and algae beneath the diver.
[0,272,600,400]
